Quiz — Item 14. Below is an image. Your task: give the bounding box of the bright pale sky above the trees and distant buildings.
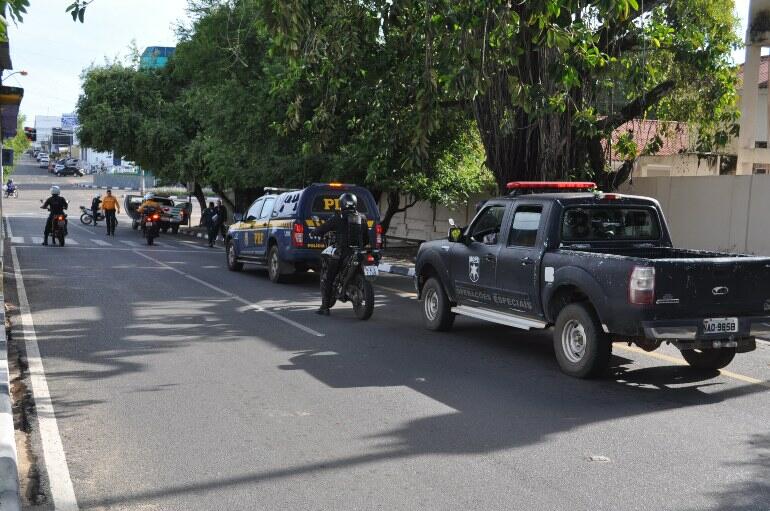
[4,0,749,126]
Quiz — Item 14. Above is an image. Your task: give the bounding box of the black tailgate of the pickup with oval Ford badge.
[654,257,770,317]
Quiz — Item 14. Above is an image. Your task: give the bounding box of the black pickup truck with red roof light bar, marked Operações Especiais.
[415,182,770,378]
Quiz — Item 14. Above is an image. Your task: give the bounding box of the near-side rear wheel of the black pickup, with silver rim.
[553,303,612,378]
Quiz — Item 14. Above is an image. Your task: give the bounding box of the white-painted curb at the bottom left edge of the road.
[0,291,21,511]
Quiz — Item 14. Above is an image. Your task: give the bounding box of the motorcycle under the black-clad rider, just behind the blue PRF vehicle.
[321,227,382,320]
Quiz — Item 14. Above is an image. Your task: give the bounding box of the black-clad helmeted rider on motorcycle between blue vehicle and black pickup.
[310,192,369,316]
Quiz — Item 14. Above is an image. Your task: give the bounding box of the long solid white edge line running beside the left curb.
[11,247,78,511]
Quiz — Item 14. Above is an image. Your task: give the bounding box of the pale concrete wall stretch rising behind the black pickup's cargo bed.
[621,175,770,256]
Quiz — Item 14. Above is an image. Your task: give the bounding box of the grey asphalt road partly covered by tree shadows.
[5,158,770,510]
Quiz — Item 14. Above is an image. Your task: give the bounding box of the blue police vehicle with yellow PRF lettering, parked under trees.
[225,183,382,282]
